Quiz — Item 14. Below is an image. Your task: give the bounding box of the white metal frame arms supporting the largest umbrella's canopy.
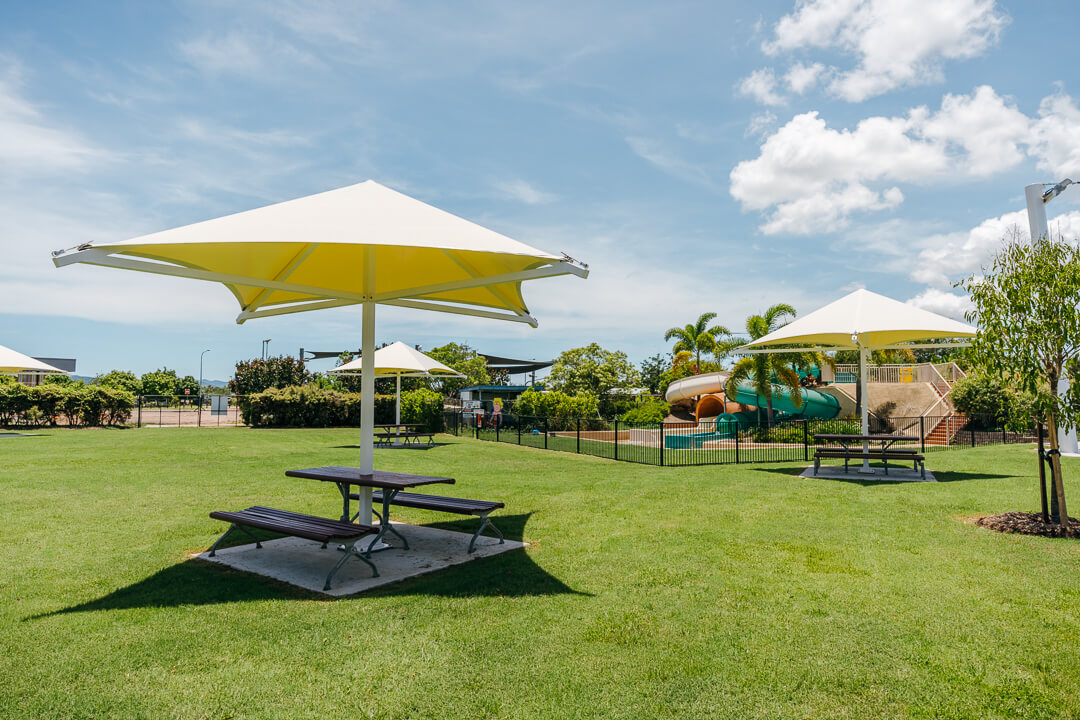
[53,245,589,327]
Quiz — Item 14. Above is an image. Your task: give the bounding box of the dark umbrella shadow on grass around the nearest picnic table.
[24,513,583,621]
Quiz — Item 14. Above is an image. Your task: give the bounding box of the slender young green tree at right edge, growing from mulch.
[957,237,1080,531]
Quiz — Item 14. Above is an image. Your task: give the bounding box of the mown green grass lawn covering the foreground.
[0,429,1080,719]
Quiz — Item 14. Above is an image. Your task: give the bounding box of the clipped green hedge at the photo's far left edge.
[0,382,135,426]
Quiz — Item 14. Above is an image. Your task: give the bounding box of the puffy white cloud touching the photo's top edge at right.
[761,0,1008,103]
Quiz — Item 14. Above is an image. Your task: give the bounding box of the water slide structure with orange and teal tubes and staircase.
[664,363,968,449]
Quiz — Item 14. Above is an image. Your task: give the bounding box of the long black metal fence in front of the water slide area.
[444,413,1037,466]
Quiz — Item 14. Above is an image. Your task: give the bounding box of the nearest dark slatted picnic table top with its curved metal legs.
[285,465,454,555]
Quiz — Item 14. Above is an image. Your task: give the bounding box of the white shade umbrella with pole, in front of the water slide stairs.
[737,289,976,467]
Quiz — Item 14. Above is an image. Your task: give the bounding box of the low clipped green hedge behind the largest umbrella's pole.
[240,383,394,427]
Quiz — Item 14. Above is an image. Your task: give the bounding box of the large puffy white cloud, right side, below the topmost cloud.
[730,85,1054,234]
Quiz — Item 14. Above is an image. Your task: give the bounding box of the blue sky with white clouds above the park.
[0,0,1080,379]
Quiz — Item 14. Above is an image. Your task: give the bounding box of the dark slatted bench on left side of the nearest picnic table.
[210,505,379,590]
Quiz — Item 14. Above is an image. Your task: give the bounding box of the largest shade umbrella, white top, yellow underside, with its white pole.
[53,180,589,511]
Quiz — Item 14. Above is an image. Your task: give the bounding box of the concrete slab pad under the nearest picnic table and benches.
[200,519,527,597]
